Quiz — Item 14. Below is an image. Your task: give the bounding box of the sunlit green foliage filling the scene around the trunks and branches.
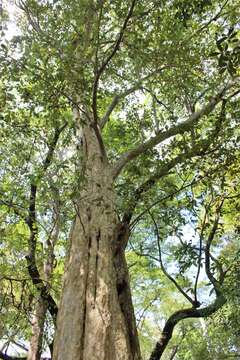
[0,0,240,360]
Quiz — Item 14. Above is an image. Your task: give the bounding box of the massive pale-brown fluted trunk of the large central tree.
[53,116,140,360]
